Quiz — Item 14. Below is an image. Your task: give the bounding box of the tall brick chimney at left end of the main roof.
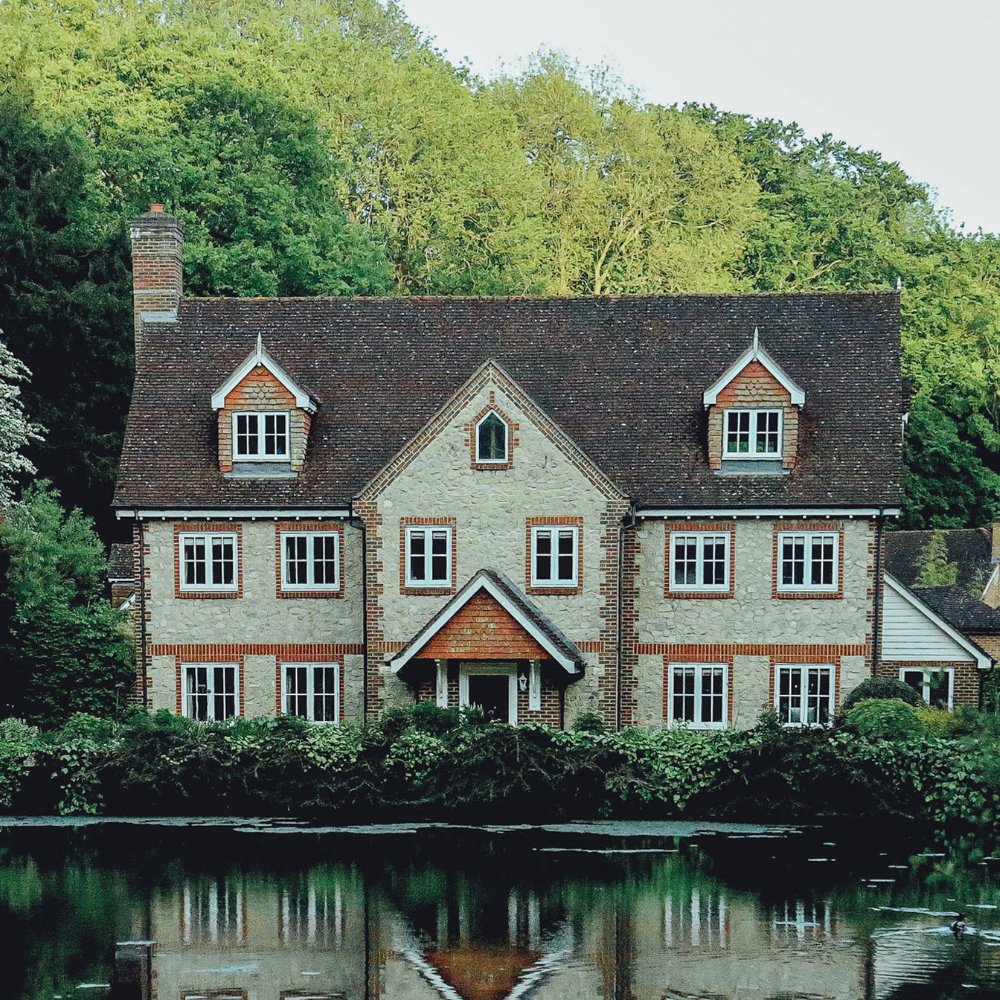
[129,205,184,353]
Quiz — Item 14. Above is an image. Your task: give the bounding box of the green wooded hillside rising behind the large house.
[0,0,1000,542]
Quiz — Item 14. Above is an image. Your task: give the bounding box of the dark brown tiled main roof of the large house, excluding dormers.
[115,292,903,508]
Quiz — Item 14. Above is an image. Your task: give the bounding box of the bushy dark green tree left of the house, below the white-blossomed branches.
[0,481,135,724]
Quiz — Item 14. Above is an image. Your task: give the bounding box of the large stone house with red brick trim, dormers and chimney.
[114,206,903,728]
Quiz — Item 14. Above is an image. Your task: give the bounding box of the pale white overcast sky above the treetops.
[399,0,1000,233]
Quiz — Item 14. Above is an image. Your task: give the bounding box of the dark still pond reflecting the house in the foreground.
[0,819,1000,1000]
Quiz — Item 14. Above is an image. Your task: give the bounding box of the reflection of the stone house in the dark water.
[115,855,876,1000]
